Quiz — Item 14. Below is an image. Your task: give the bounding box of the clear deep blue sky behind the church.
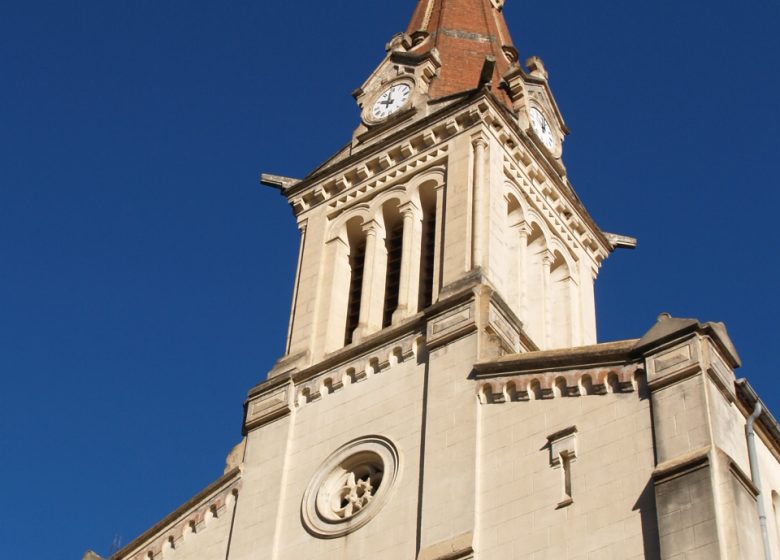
[0,0,780,559]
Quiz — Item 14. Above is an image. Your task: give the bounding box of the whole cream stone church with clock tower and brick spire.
[94,0,780,560]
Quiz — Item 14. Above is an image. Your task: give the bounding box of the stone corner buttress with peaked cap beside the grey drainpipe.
[637,316,763,560]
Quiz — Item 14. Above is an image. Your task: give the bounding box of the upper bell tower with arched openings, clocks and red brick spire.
[262,0,620,373]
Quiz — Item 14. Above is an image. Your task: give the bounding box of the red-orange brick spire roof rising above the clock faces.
[407,0,518,106]
